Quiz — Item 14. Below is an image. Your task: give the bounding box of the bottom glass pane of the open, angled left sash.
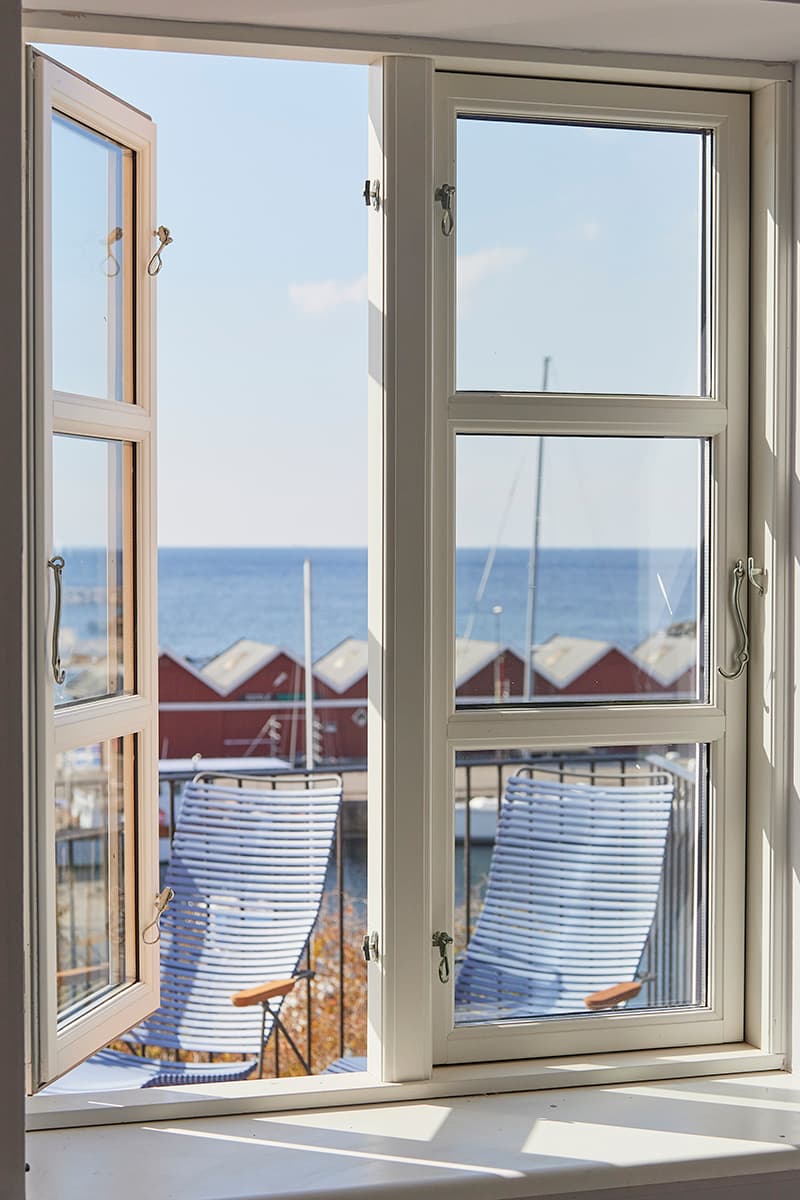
[54,738,134,1021]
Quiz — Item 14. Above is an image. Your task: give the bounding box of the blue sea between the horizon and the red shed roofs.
[153,547,698,661]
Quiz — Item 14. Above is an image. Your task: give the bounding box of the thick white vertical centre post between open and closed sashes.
[369,56,433,1081]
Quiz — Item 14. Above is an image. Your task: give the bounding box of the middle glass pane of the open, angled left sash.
[53,434,134,706]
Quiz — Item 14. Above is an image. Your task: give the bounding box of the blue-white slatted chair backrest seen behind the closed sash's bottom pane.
[456,772,674,1024]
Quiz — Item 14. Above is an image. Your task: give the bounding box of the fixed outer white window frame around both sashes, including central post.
[18,13,792,1128]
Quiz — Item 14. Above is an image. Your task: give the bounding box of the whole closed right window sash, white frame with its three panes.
[431,72,748,1063]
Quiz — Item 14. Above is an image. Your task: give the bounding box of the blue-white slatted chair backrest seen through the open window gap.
[128,775,342,1054]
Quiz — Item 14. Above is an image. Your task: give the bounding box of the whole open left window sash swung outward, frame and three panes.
[29,52,158,1092]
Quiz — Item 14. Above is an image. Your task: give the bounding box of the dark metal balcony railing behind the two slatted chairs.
[56,751,706,1076]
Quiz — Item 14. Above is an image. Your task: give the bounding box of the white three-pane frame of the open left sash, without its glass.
[30,54,160,1088]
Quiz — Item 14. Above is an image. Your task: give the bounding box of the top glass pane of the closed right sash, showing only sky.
[456,116,710,396]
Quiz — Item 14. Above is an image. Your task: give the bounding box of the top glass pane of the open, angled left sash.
[52,113,133,401]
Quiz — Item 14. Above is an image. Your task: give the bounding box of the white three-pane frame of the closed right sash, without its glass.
[431,72,757,1062]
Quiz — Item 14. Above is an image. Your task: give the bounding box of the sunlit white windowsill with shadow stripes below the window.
[28,1072,800,1200]
